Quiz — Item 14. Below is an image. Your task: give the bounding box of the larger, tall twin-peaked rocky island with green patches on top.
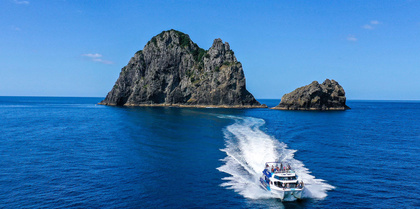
[99,30,266,107]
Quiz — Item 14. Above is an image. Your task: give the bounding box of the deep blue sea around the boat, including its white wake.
[0,97,420,208]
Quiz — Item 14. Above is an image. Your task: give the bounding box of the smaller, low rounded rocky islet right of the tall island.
[273,79,350,110]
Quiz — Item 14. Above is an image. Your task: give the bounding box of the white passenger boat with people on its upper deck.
[260,162,305,201]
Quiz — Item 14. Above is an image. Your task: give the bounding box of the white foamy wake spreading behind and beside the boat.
[217,116,334,199]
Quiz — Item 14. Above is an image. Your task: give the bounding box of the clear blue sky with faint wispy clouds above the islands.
[0,0,420,100]
